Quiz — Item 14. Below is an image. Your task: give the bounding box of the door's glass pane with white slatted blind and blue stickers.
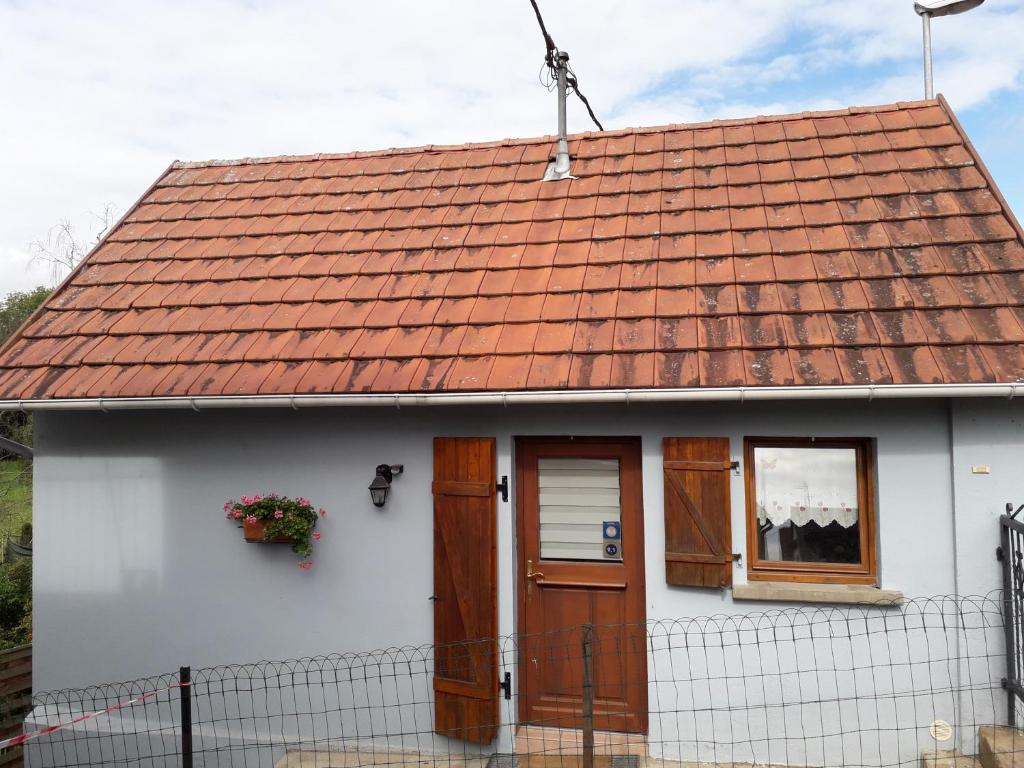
[537,459,622,560]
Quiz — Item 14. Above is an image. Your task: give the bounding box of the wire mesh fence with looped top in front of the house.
[26,595,1024,768]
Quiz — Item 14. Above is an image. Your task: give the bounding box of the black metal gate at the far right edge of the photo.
[995,504,1024,726]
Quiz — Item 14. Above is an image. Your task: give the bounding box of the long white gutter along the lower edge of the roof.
[0,382,1024,412]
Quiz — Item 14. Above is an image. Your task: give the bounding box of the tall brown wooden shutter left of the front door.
[433,437,498,744]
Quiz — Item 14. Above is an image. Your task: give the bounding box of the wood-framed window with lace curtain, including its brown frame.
[744,437,877,585]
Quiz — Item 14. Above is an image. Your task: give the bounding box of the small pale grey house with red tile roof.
[0,98,1024,765]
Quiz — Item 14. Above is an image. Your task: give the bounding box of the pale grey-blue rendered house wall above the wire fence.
[28,400,1011,765]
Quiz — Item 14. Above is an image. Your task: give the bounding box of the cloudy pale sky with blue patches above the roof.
[0,0,1024,297]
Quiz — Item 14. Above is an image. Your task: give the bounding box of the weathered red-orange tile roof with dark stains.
[0,100,1024,400]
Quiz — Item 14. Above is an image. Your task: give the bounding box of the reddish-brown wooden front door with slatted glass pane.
[516,438,647,733]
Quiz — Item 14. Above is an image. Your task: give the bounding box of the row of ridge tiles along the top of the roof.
[165,94,942,175]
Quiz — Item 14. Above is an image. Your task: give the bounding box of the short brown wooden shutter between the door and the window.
[664,437,732,587]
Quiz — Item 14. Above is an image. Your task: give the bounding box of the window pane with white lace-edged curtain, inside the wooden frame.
[754,445,862,563]
